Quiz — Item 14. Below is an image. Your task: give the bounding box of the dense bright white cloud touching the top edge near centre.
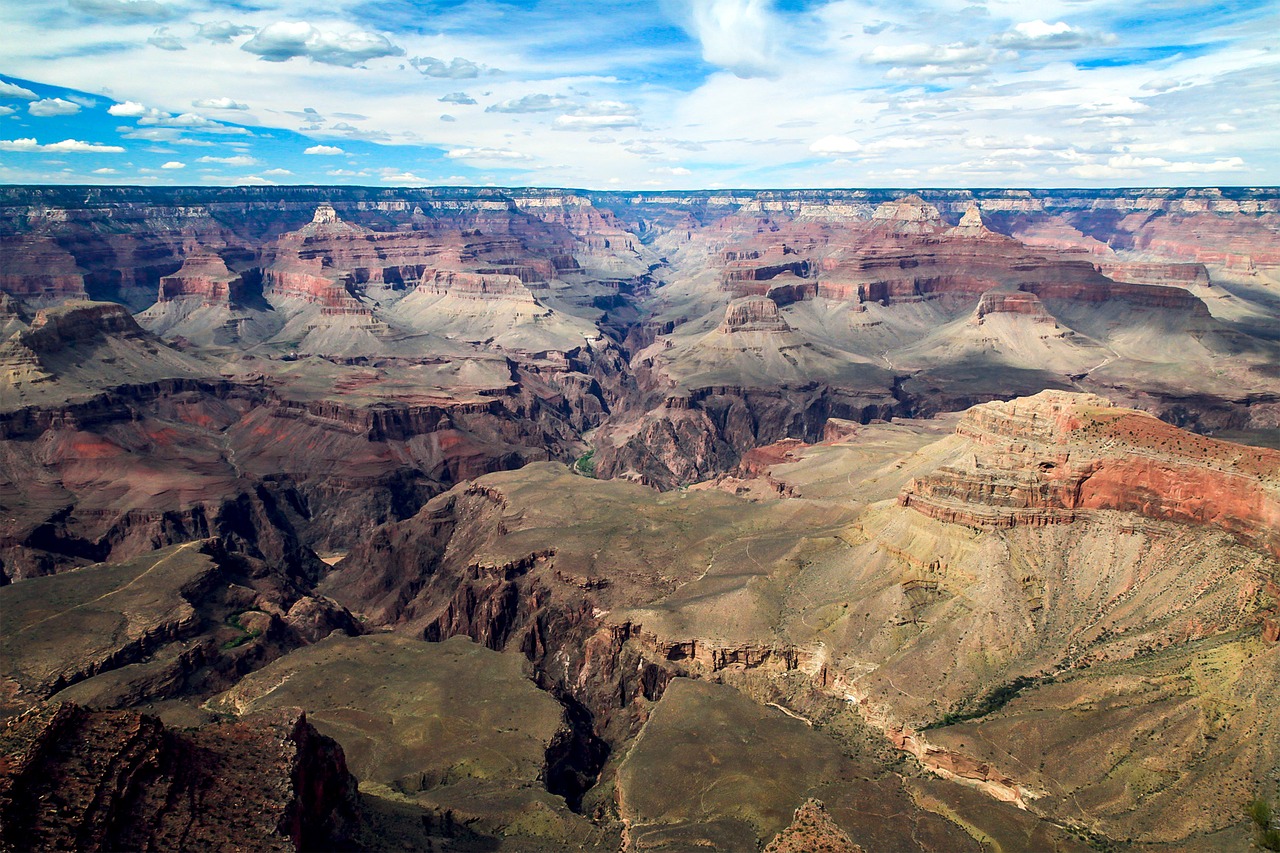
[685,0,782,77]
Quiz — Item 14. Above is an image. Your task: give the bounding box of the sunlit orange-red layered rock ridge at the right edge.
[899,392,1280,556]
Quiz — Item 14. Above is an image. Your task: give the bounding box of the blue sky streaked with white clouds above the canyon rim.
[0,0,1280,190]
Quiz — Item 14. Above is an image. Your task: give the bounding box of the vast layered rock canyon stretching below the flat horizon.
[0,187,1280,852]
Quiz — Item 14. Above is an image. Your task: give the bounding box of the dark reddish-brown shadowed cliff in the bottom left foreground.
[0,704,357,850]
